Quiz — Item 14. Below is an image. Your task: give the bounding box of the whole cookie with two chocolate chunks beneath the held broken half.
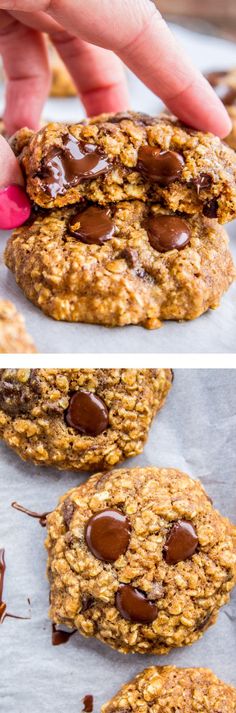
[5,201,235,329]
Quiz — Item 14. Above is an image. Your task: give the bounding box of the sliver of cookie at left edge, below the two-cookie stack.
[0,299,36,354]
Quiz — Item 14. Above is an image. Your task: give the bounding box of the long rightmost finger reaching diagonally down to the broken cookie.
[1,0,231,137]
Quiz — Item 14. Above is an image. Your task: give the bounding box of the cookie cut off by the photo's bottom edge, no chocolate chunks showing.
[101,666,236,713]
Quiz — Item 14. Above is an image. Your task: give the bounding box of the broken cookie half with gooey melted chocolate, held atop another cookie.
[12,112,236,223]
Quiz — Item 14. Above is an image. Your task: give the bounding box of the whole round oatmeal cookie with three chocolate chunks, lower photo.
[46,467,236,652]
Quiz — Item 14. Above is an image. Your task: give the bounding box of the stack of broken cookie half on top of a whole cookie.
[5,113,236,328]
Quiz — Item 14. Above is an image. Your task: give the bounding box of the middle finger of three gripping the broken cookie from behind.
[51,33,129,116]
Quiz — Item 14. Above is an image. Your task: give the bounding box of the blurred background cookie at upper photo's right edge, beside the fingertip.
[206,68,236,151]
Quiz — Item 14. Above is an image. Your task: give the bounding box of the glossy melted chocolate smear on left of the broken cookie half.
[40,134,110,198]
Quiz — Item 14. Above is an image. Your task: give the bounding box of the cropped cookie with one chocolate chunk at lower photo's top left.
[0,369,172,470]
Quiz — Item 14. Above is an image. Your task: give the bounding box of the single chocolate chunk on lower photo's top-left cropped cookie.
[65,391,109,436]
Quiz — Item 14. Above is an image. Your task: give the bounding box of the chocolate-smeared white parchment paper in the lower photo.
[0,370,236,713]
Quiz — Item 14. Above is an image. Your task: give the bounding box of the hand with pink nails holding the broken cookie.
[0,0,231,227]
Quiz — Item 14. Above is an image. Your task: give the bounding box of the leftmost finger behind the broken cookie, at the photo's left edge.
[0,12,50,134]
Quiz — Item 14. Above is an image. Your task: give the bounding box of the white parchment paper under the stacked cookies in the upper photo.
[0,26,236,353]
